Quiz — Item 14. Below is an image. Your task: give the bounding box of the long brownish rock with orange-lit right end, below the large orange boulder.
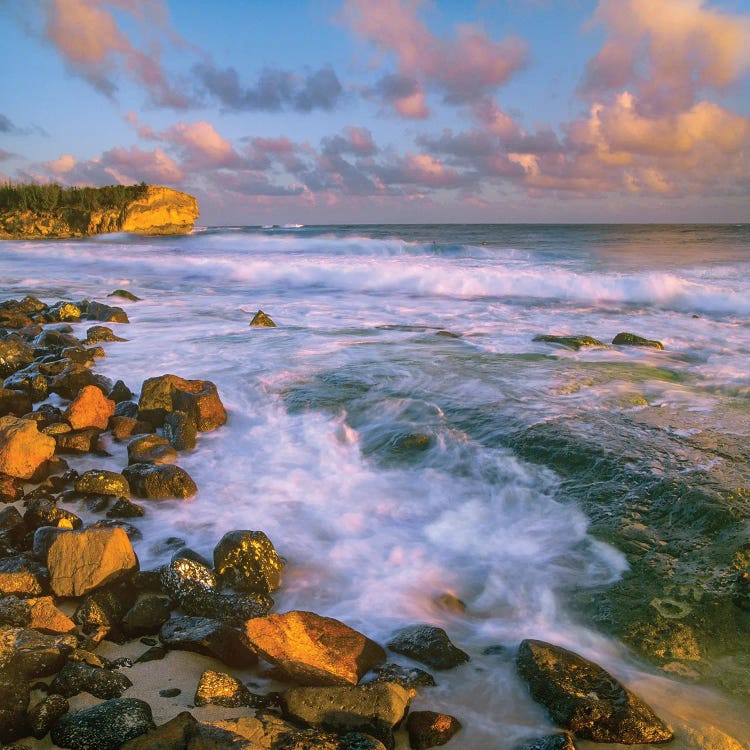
[281,683,409,748]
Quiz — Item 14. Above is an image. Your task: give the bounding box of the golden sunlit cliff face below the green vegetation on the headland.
[0,187,199,239]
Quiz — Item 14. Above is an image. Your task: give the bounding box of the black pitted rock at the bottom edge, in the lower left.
[50,698,155,750]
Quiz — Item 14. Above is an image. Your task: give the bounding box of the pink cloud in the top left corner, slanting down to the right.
[45,0,188,108]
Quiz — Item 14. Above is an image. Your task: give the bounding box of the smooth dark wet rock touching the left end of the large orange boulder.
[159,617,258,667]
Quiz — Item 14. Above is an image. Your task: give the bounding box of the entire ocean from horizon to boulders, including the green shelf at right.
[0,225,750,750]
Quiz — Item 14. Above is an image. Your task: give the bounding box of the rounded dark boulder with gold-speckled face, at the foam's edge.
[214,531,284,594]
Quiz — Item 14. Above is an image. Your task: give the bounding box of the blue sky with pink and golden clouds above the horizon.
[0,0,750,226]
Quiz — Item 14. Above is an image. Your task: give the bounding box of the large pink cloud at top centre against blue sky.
[344,0,527,118]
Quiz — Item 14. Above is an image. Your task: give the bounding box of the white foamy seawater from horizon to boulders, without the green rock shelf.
[0,227,750,749]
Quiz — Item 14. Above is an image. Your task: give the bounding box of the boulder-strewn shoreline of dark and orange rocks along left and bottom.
[0,290,716,750]
